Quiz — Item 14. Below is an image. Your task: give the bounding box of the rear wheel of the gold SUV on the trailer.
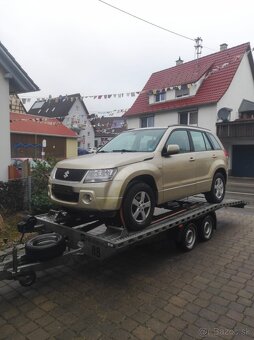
[205,172,226,203]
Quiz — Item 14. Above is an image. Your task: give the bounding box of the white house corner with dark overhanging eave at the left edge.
[0,42,39,181]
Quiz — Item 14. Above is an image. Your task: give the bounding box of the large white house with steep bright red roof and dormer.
[124,43,254,176]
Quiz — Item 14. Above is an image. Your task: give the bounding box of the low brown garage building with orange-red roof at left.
[10,112,78,160]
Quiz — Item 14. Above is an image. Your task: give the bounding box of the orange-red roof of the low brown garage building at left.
[10,112,77,138]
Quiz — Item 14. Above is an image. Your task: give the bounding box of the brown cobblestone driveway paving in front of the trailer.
[0,208,254,340]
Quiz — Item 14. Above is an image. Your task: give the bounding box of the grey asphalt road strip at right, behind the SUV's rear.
[226,177,254,214]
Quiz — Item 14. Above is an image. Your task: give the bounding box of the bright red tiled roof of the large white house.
[124,43,250,117]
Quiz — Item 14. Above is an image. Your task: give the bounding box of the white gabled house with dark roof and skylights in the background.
[28,93,94,150]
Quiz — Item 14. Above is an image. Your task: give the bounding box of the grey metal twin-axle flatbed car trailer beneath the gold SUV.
[0,197,247,286]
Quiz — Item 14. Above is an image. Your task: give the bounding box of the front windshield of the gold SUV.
[98,128,166,152]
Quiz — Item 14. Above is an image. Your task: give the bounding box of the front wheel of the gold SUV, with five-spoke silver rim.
[122,182,155,231]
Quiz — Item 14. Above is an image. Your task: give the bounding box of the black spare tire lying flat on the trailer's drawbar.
[25,233,66,261]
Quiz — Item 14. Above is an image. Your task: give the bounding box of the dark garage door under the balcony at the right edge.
[232,145,254,177]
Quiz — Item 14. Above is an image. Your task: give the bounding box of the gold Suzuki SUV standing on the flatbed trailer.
[49,125,228,230]
